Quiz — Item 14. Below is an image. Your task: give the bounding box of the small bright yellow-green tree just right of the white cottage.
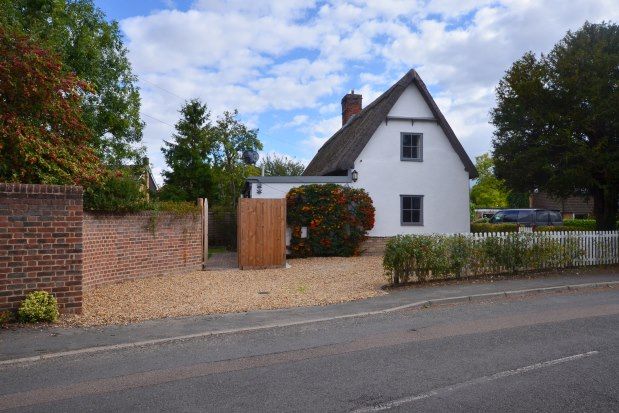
[471,153,509,208]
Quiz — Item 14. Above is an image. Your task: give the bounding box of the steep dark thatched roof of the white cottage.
[303,69,477,179]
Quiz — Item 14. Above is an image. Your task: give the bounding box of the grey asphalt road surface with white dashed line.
[0,289,619,413]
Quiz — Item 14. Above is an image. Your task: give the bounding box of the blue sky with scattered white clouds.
[95,0,619,184]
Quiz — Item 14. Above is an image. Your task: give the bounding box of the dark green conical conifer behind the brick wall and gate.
[159,99,217,202]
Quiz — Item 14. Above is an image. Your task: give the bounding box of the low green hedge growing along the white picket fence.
[383,233,583,284]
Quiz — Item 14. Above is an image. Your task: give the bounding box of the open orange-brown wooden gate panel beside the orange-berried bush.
[236,198,286,270]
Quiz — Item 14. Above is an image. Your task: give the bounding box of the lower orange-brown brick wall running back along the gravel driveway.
[83,212,202,289]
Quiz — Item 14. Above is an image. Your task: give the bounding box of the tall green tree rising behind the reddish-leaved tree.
[0,0,144,166]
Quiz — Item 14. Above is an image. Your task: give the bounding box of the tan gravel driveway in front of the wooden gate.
[68,257,386,326]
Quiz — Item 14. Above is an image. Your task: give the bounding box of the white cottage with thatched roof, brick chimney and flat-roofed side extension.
[245,70,477,237]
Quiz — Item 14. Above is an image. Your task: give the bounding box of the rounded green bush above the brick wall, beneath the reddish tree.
[84,170,149,212]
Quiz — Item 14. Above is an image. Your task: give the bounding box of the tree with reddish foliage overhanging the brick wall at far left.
[0,26,103,185]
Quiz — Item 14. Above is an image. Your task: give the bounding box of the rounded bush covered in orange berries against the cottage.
[286,184,375,257]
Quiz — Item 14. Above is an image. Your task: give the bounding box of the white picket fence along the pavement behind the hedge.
[469,230,619,266]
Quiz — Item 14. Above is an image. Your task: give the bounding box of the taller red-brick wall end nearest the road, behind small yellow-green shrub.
[0,183,82,313]
